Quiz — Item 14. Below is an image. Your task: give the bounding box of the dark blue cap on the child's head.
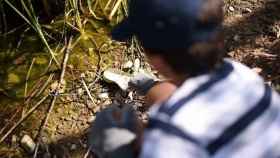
[112,0,220,50]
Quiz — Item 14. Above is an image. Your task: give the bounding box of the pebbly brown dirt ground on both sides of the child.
[0,0,280,158]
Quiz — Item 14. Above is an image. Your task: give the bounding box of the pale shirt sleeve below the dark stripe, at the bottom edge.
[140,129,208,158]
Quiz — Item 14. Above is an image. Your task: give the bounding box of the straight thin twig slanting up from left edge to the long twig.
[0,95,49,143]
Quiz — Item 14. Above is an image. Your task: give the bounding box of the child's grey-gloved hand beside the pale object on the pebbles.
[128,71,158,95]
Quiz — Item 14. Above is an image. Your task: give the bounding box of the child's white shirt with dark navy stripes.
[140,59,280,158]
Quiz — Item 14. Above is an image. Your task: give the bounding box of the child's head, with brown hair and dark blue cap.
[112,0,224,83]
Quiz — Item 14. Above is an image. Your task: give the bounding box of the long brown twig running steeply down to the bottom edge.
[33,37,72,158]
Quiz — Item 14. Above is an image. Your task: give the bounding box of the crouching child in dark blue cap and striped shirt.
[89,0,280,158]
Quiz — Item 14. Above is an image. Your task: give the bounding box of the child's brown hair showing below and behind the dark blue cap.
[145,0,224,76]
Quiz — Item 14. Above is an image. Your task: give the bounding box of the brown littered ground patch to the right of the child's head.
[225,0,280,87]
